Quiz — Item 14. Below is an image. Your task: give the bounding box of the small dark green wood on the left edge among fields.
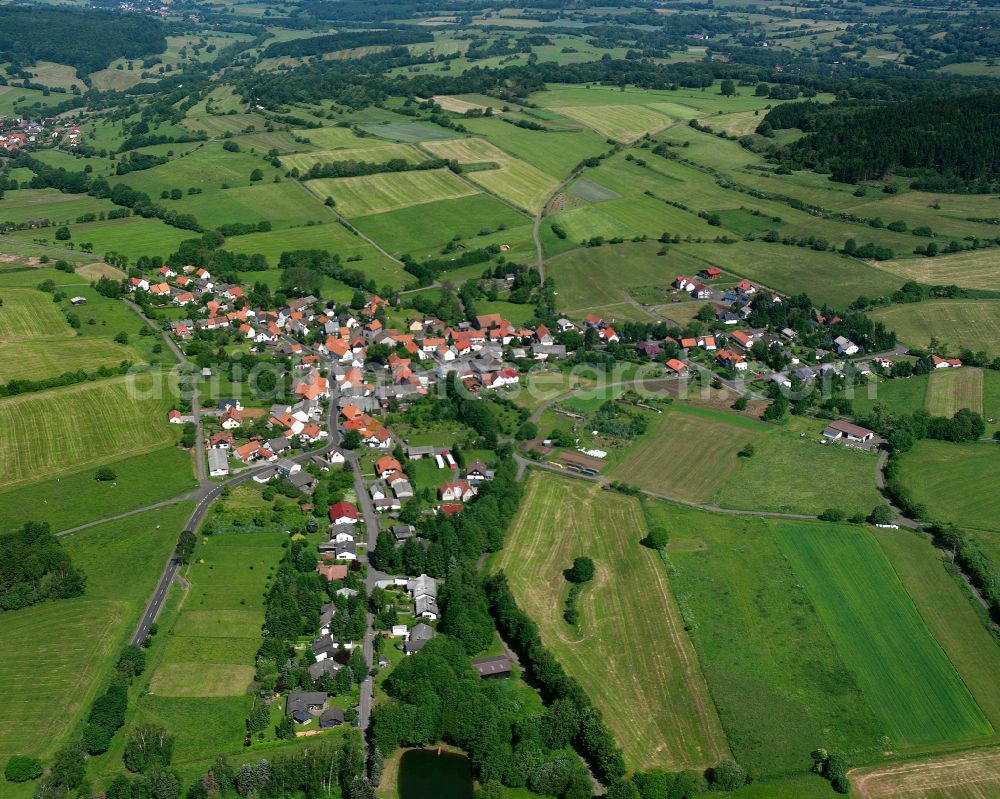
[0,522,87,610]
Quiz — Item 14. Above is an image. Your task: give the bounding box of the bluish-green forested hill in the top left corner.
[0,6,167,77]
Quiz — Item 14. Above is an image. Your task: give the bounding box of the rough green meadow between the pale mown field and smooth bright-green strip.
[646,502,883,780]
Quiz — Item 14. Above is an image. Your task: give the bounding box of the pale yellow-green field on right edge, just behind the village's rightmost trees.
[869,300,1000,356]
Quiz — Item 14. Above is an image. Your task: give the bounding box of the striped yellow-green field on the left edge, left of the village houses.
[0,375,174,488]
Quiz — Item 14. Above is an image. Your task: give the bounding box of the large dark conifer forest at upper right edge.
[758,94,1000,192]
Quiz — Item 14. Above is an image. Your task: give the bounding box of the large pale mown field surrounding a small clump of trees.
[496,474,729,770]
